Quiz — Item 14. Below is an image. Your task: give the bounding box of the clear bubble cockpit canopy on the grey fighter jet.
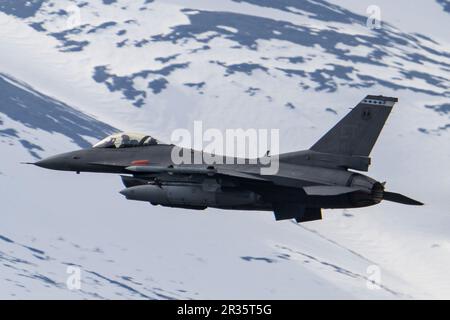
[93,132,161,149]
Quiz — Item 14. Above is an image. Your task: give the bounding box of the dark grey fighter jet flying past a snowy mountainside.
[34,95,423,223]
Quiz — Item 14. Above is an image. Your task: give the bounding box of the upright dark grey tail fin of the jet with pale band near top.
[311,95,398,157]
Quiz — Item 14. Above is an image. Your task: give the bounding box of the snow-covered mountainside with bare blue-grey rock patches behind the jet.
[0,0,450,299]
